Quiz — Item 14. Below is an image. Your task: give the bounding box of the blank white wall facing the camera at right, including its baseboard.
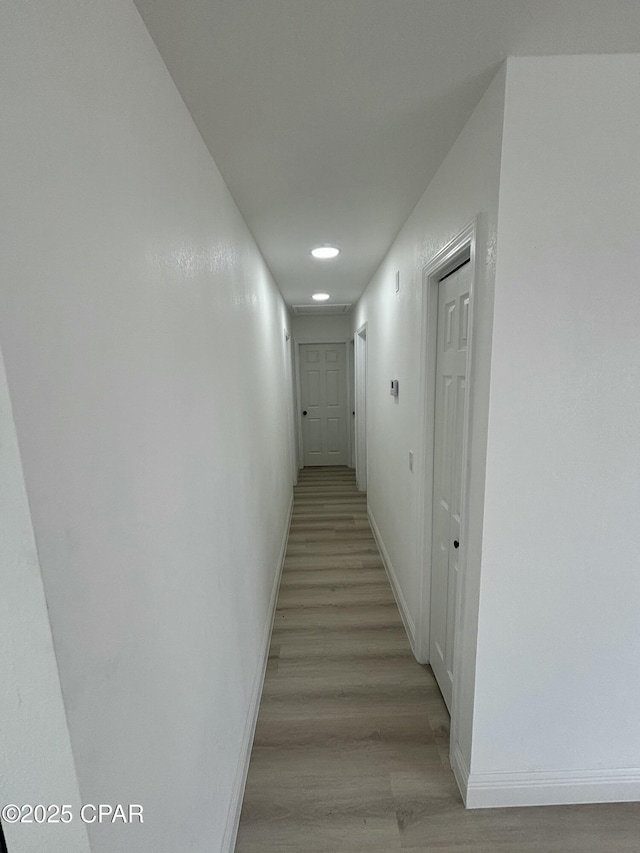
[468,55,640,806]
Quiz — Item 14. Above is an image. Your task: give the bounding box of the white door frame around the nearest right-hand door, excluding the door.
[416,219,479,732]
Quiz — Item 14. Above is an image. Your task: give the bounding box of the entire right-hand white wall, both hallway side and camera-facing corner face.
[354,50,640,807]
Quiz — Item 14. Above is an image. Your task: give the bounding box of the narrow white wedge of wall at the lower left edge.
[0,346,89,853]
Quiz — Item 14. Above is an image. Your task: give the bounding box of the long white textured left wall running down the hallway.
[0,0,292,853]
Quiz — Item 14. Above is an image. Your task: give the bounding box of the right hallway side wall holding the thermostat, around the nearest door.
[352,70,504,761]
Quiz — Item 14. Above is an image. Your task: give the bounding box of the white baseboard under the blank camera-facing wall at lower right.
[465,767,640,809]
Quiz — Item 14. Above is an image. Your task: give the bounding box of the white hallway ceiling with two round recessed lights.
[135,0,640,304]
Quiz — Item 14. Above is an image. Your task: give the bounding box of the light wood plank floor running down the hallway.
[236,468,640,853]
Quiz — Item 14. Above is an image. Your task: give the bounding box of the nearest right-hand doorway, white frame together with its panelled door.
[418,221,476,745]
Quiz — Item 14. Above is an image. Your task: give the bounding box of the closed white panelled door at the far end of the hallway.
[300,344,348,466]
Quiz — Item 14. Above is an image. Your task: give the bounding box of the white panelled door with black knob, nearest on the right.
[430,262,471,710]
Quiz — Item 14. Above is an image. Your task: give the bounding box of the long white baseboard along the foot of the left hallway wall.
[222,493,293,853]
